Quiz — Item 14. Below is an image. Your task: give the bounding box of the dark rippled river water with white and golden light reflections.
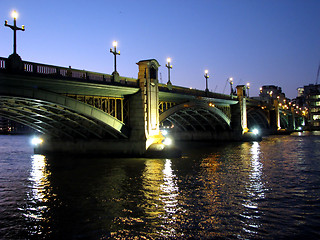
[0,132,320,239]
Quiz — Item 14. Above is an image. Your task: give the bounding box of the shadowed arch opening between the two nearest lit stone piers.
[160,102,230,132]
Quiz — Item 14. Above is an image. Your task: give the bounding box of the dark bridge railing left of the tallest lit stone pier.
[0,57,138,87]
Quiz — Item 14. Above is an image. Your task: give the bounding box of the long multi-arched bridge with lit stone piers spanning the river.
[0,58,301,155]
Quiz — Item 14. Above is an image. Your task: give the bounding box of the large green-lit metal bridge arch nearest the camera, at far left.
[0,86,128,139]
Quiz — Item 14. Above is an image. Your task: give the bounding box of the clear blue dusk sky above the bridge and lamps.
[0,0,320,98]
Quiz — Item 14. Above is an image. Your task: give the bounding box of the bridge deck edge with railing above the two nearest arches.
[0,57,237,104]
